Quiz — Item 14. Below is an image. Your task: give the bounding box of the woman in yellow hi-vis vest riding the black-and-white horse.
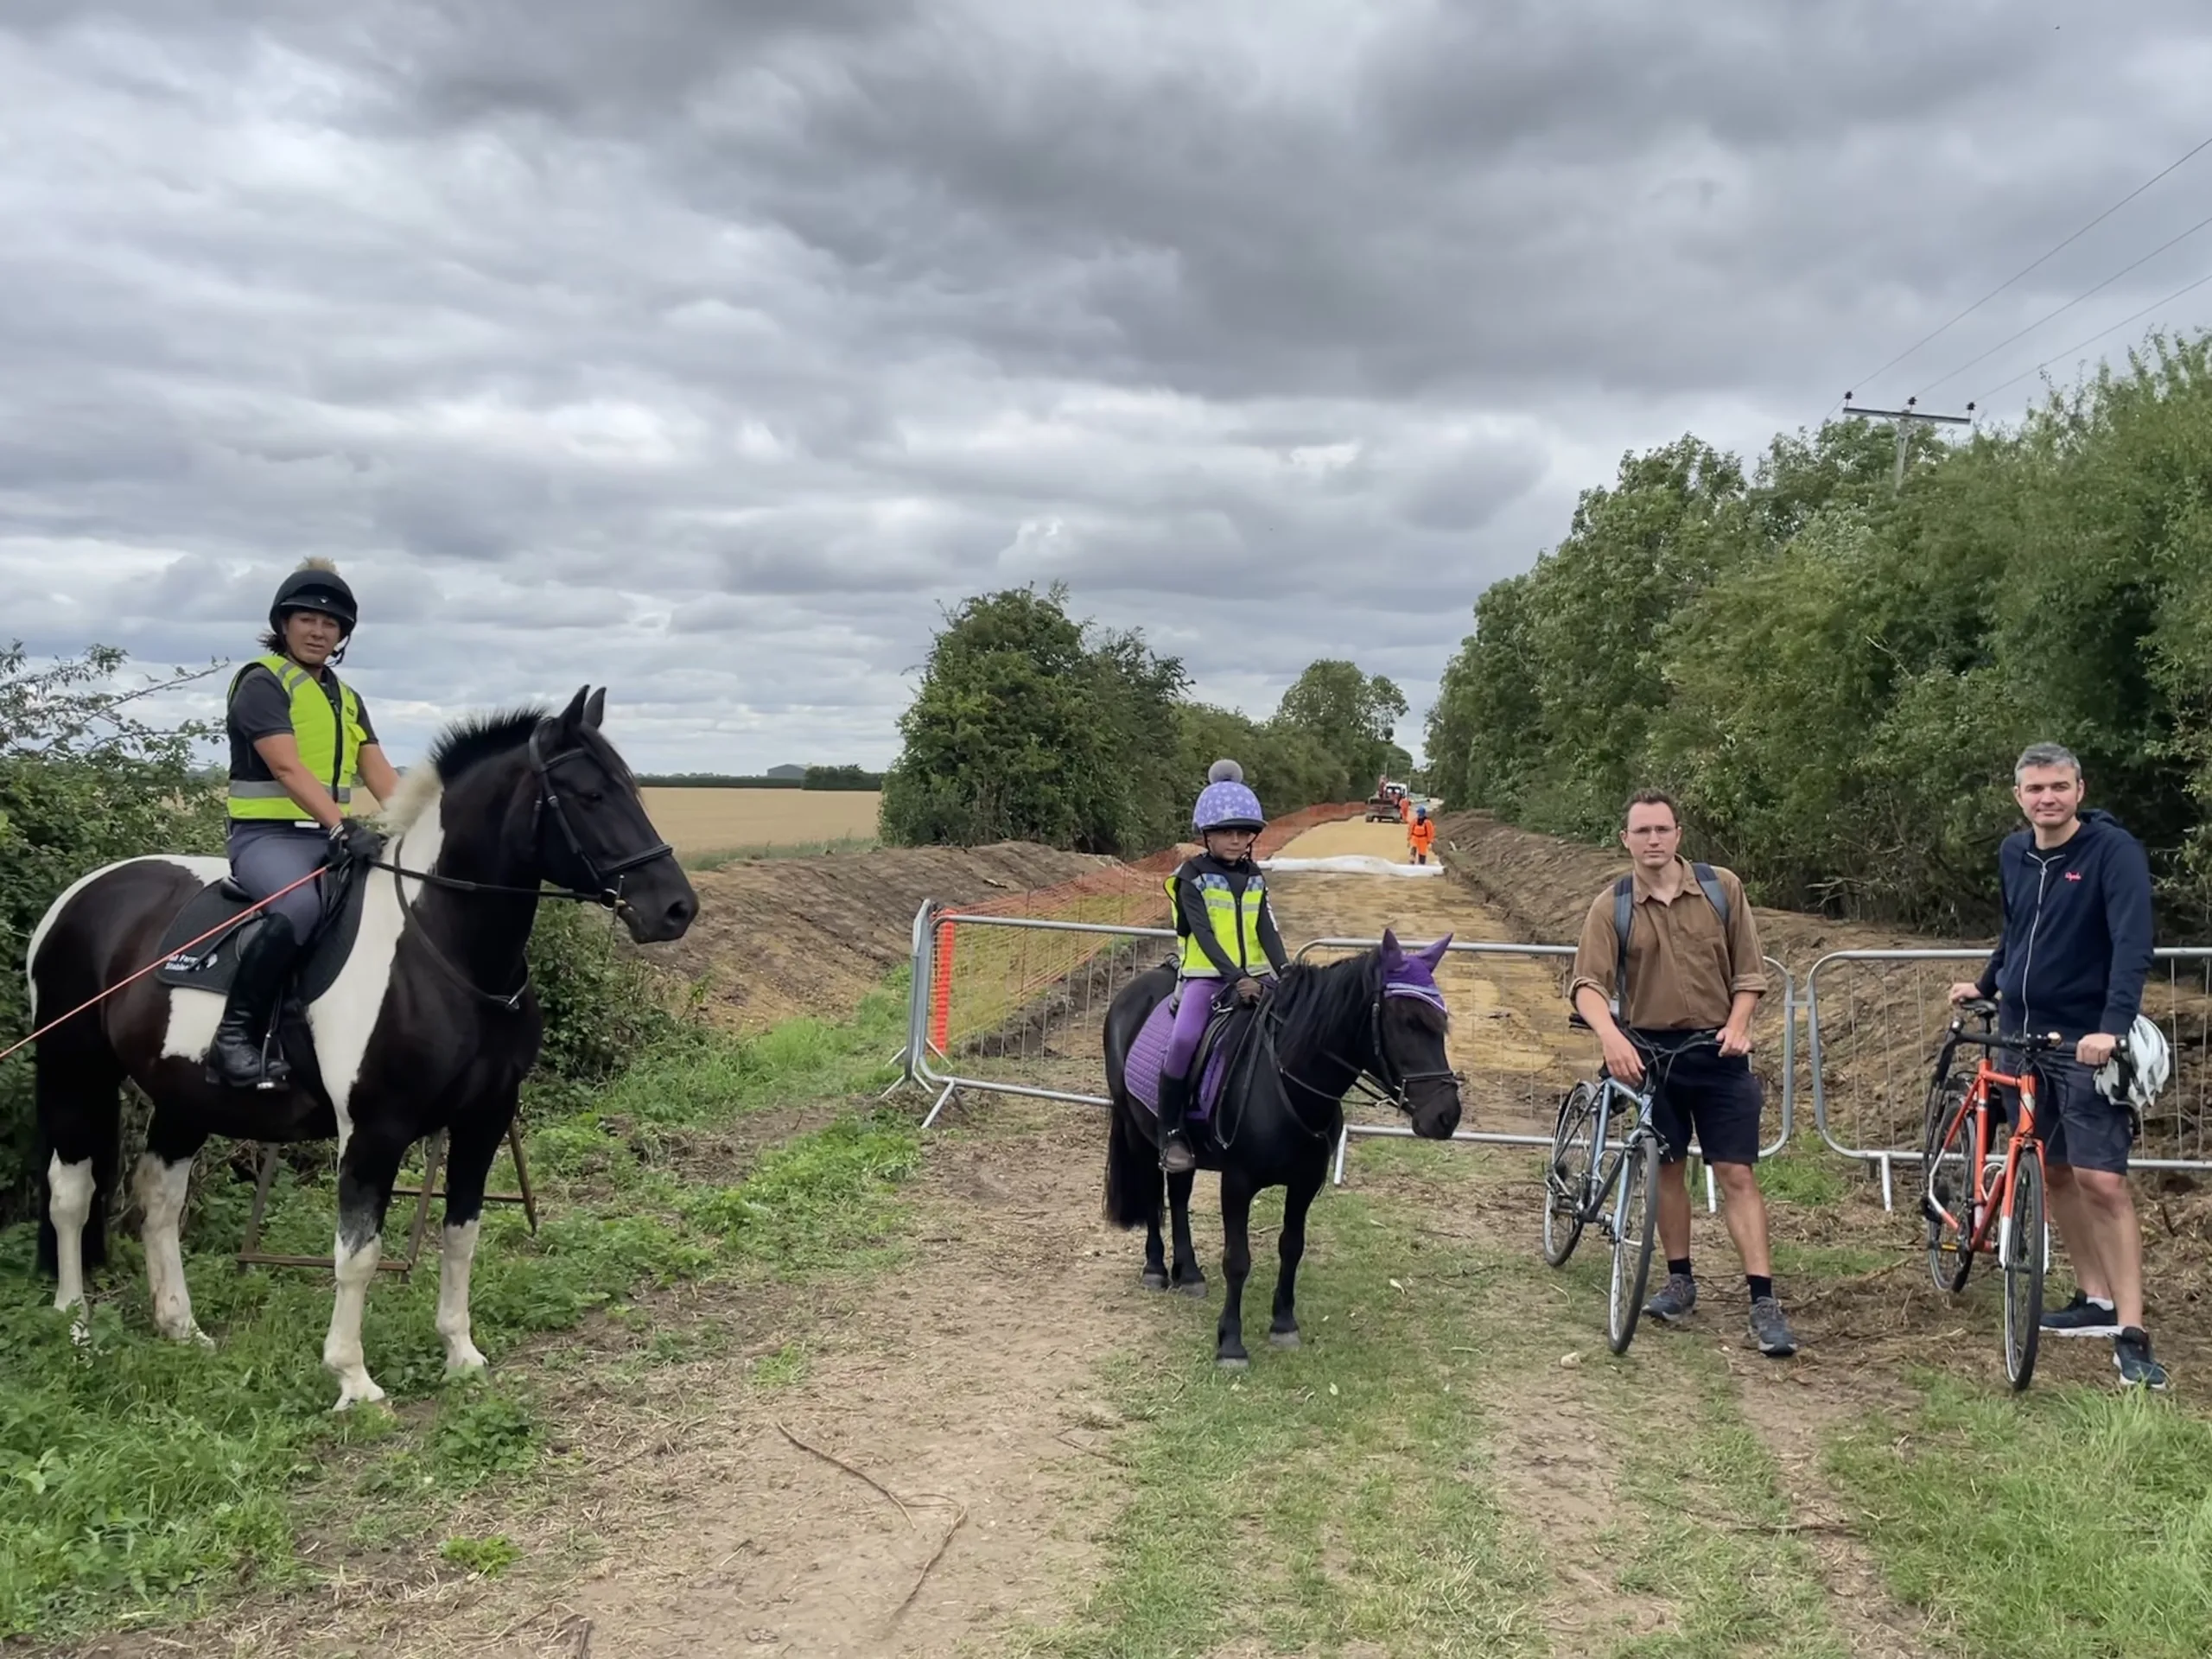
[208,560,398,1089]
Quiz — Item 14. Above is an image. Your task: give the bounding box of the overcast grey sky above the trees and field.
[0,0,2212,770]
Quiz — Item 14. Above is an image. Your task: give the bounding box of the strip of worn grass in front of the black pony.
[1028,1194,1544,1659]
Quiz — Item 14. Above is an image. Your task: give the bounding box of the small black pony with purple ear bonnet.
[1106,931,1460,1370]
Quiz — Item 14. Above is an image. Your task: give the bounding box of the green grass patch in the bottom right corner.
[1827,1378,2212,1659]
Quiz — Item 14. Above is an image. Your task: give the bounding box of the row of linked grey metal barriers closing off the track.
[900,902,2212,1208]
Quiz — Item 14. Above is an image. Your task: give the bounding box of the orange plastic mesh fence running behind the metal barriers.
[929,803,1365,1055]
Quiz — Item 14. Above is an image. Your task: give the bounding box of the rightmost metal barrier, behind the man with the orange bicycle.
[1805,947,2212,1208]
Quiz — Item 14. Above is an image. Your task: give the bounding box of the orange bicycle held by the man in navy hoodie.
[1920,1000,2063,1391]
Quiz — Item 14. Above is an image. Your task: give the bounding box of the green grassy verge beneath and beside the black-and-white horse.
[0,988,920,1637]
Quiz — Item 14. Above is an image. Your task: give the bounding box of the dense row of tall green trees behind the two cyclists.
[1429,336,2212,936]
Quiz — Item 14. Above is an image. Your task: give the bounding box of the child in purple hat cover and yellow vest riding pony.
[1159,761,1289,1174]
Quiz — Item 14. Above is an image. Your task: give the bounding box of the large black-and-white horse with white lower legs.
[24,688,699,1409]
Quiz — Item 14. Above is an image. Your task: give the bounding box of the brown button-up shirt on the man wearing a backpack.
[1566,858,1767,1031]
